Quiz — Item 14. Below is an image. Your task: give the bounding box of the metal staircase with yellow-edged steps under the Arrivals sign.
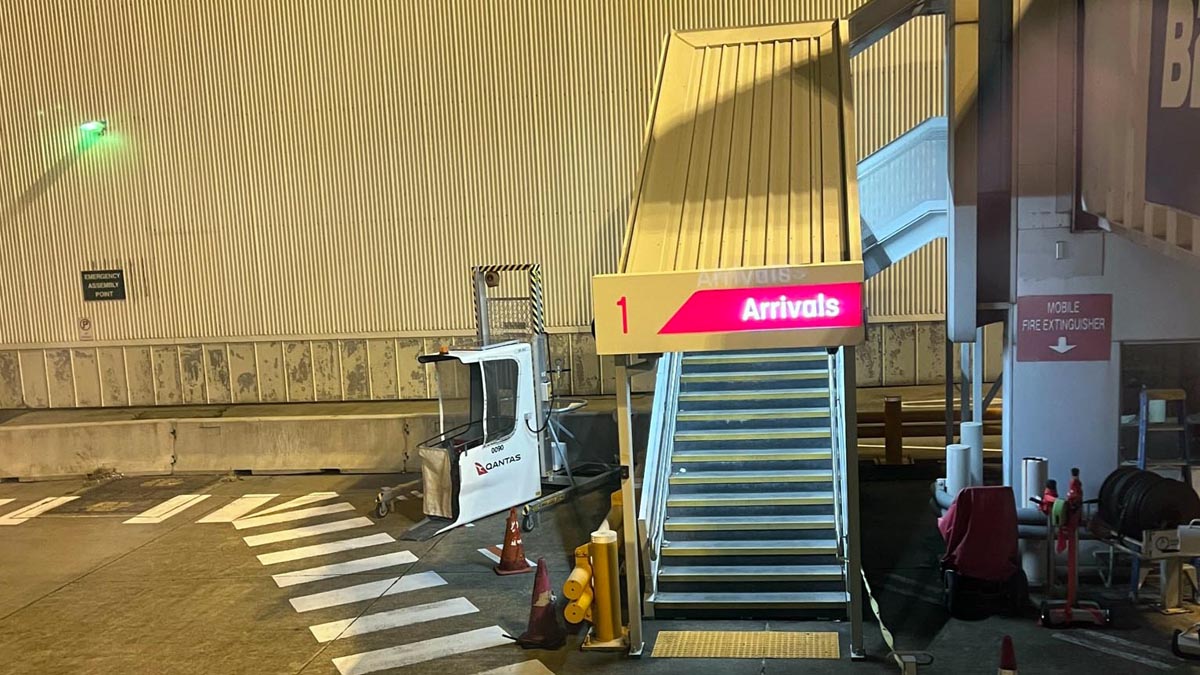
[647,350,850,616]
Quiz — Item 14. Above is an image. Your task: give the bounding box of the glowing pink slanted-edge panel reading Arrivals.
[659,282,863,335]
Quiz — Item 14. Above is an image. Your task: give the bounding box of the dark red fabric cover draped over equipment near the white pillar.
[937,485,1020,581]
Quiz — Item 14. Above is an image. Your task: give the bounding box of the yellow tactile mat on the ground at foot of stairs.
[653,631,841,658]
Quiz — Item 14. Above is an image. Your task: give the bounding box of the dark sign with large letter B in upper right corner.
[1146,0,1200,215]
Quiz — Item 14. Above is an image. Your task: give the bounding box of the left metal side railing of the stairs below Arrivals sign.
[637,352,683,597]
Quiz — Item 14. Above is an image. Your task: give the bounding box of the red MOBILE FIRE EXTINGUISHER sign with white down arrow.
[1016,294,1112,362]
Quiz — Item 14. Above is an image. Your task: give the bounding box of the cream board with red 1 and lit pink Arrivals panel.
[593,263,864,354]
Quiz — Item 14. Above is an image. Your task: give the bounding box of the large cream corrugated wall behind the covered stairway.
[0,0,942,345]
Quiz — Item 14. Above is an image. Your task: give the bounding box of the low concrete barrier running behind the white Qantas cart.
[0,413,648,480]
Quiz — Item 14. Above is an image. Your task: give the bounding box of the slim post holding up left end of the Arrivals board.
[613,356,643,656]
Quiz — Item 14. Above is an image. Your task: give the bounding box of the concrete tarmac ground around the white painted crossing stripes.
[0,474,1198,675]
